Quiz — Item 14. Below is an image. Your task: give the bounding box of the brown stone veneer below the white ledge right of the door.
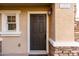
[49,44,79,56]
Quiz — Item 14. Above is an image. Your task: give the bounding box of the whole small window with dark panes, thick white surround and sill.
[1,10,21,36]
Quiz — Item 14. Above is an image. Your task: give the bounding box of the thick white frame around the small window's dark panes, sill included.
[0,10,21,36]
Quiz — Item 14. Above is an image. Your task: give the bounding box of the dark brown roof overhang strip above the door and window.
[0,3,51,6]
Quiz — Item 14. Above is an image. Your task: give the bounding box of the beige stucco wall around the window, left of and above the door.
[0,6,49,55]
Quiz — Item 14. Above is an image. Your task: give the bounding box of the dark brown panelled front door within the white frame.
[30,14,46,50]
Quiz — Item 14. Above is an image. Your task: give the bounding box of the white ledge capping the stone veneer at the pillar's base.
[49,39,79,47]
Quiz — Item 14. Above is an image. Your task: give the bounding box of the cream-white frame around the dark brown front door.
[27,11,49,54]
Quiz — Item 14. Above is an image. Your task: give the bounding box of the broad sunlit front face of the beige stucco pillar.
[55,4,74,42]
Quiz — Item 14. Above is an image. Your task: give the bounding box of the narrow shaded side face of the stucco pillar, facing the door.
[49,4,55,41]
